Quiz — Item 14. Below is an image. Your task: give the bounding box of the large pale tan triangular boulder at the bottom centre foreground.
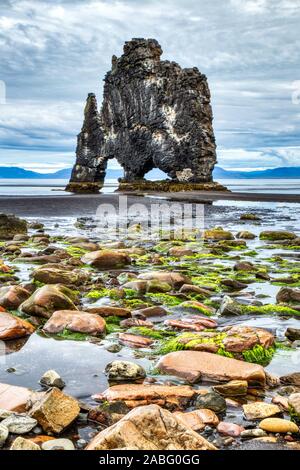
[87,405,215,451]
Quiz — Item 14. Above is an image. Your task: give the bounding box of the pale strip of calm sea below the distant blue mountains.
[0,179,300,196]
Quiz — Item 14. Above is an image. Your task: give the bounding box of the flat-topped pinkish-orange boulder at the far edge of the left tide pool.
[43,310,106,336]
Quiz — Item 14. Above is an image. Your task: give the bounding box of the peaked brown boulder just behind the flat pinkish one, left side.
[20,284,77,318]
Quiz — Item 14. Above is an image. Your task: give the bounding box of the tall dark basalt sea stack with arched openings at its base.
[67,39,217,192]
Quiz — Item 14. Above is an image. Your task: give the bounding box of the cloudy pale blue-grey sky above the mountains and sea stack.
[0,0,300,171]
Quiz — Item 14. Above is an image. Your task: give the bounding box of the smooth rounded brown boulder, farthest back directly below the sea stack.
[81,250,131,269]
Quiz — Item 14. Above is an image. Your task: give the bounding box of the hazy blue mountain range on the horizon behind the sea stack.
[0,166,300,180]
